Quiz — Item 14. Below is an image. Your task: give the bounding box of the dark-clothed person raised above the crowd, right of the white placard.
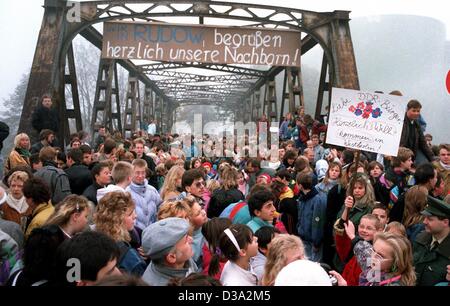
[400,100,434,165]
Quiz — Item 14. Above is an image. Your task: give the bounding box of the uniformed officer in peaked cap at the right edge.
[413,196,450,286]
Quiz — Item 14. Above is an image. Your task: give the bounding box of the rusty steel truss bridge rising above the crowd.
[19,0,359,141]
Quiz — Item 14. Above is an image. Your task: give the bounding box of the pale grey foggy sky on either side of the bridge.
[0,0,450,143]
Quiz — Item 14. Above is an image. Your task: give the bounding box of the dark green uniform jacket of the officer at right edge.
[413,232,450,286]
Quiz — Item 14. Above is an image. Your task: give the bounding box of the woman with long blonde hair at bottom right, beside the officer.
[364,233,416,286]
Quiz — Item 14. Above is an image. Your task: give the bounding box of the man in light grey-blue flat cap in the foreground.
[142,218,197,286]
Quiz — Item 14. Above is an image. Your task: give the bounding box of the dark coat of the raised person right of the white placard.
[400,115,434,162]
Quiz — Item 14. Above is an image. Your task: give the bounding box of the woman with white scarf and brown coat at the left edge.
[0,171,32,229]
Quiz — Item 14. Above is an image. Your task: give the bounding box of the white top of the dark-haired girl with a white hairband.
[220,260,258,286]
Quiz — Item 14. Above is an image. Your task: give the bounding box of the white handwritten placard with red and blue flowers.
[327,88,407,156]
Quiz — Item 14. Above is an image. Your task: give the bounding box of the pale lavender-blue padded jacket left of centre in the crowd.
[126,180,162,230]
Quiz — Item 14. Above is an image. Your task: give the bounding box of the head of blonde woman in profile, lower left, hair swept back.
[45,194,91,239]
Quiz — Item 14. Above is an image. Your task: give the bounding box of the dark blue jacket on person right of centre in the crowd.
[297,187,327,247]
